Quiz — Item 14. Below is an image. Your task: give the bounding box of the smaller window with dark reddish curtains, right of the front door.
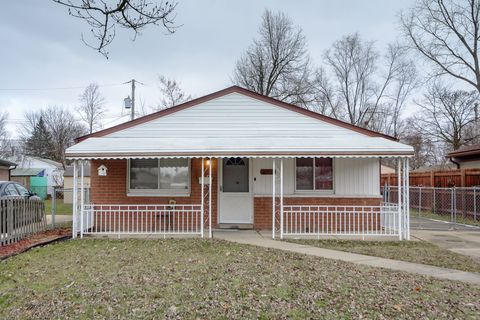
[295,158,333,191]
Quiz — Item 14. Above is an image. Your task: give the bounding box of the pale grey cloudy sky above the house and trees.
[0,0,413,136]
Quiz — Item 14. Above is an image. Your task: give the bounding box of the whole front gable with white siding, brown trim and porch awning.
[66,87,413,159]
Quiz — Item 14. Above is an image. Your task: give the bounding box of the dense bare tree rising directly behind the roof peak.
[232,10,314,106]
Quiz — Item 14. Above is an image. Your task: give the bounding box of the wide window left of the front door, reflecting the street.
[129,159,189,195]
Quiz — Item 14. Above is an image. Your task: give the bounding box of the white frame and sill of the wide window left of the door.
[126,158,192,197]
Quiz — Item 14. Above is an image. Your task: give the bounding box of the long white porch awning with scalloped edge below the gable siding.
[67,135,413,159]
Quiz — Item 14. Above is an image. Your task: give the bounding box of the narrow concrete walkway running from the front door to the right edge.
[213,230,480,285]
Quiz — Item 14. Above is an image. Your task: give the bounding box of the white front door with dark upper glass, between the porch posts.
[219,157,253,224]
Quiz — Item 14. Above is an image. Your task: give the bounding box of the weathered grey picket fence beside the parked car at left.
[0,198,47,246]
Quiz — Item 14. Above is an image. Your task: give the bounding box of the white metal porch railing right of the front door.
[282,203,405,236]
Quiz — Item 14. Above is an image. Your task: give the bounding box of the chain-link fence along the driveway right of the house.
[382,186,480,230]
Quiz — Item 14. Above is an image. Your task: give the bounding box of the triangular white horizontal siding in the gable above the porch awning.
[106,93,365,140]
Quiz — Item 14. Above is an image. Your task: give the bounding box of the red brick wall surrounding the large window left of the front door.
[90,159,217,226]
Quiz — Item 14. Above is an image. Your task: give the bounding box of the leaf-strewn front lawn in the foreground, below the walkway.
[0,239,480,319]
